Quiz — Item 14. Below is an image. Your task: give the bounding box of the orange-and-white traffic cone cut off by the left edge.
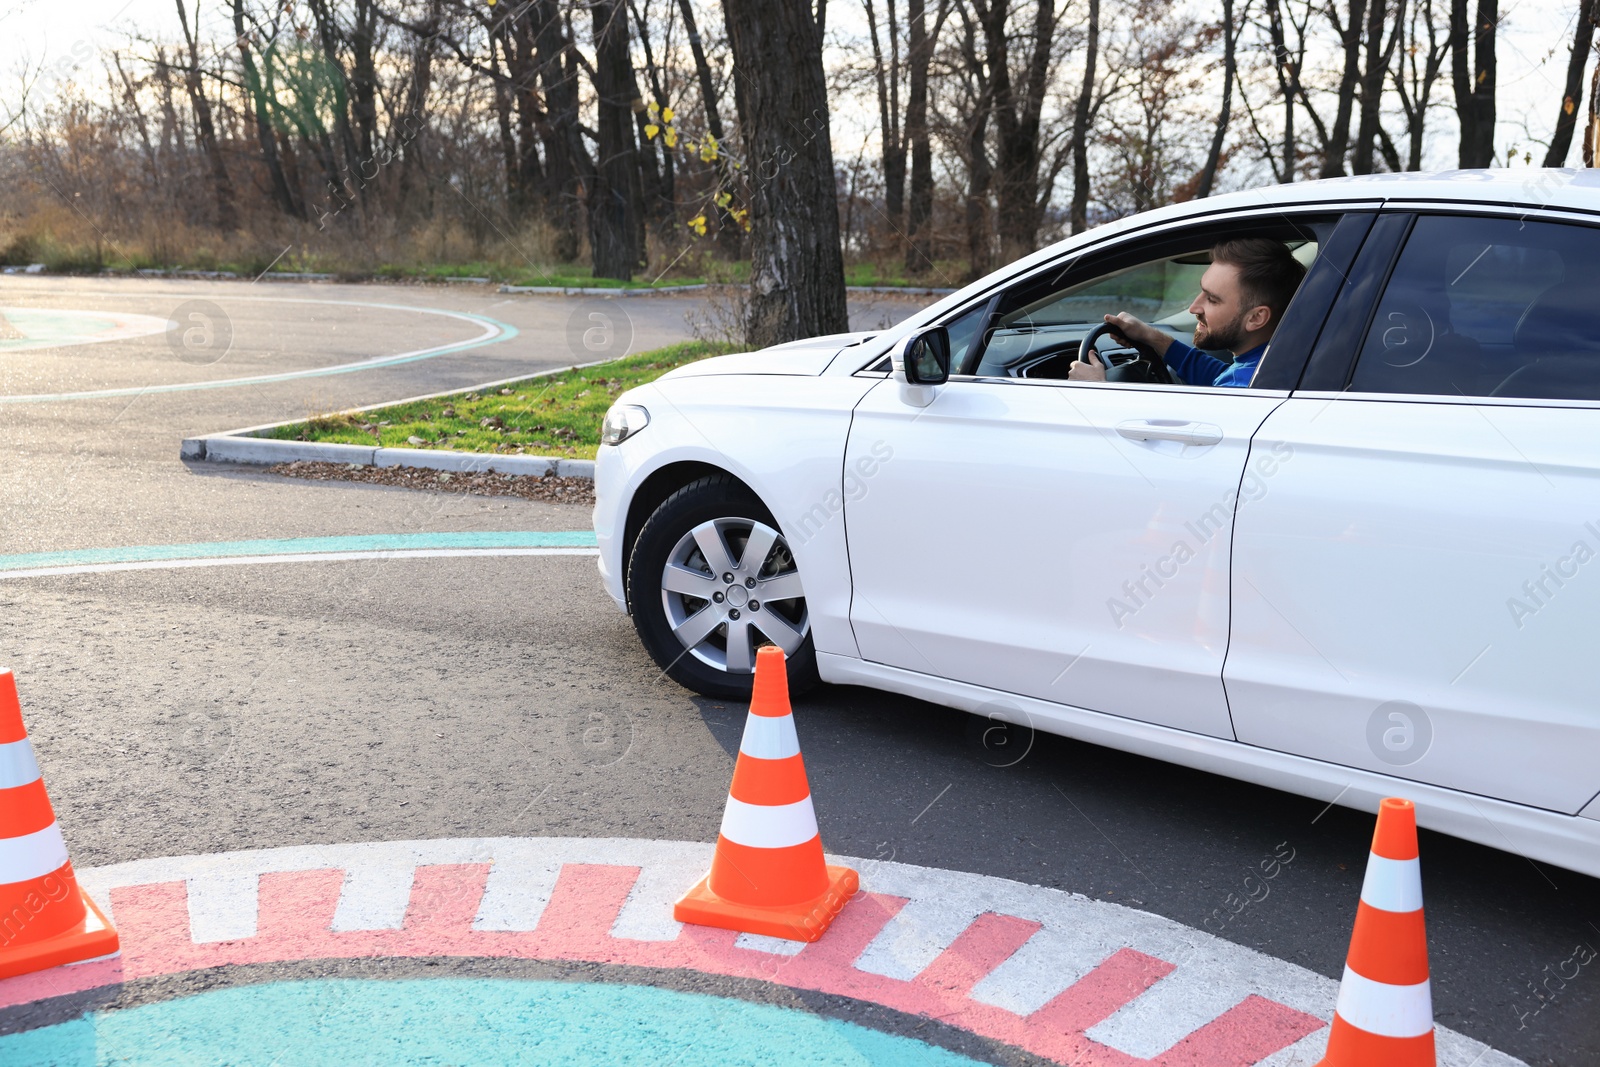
[0,670,117,979]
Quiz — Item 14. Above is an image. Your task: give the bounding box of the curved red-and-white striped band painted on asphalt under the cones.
[0,838,1520,1067]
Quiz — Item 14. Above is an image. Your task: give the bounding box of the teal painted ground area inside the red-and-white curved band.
[0,979,978,1067]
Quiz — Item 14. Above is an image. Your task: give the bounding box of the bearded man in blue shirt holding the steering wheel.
[1067,237,1306,389]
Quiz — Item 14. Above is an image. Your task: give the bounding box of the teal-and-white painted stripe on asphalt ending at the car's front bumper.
[0,530,598,579]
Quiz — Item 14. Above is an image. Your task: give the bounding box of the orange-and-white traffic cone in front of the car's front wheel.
[672,645,861,941]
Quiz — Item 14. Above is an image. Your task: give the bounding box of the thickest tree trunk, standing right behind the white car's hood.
[722,0,850,347]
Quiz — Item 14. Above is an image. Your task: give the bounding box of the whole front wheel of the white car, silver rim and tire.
[627,475,816,699]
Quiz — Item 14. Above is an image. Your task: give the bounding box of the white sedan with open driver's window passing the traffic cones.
[594,170,1600,875]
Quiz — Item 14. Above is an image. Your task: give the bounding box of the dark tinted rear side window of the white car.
[1349,216,1600,400]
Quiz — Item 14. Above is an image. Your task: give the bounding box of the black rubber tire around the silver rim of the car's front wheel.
[627,475,818,701]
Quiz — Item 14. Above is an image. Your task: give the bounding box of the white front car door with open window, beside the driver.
[845,209,1358,737]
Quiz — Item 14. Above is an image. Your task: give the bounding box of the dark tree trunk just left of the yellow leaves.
[589,0,645,282]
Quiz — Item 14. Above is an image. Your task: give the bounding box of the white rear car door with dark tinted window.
[1224,211,1600,813]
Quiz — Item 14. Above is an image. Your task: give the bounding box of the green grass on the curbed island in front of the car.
[266,341,734,459]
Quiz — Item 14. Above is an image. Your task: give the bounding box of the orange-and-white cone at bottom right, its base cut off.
[1318,797,1437,1067]
